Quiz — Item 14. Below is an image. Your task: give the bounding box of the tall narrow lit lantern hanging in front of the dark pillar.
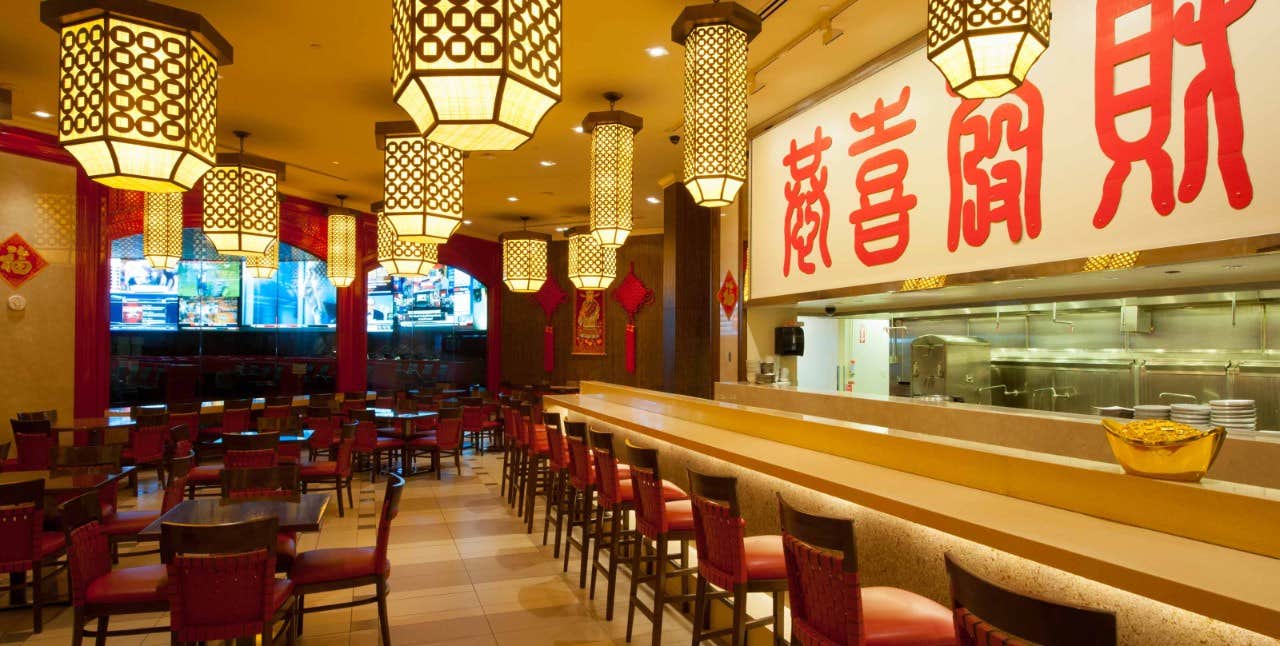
[671,3,760,207]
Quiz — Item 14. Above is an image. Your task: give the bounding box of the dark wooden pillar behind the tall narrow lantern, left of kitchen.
[662,184,719,398]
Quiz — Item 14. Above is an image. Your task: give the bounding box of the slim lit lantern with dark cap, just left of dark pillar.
[582,92,644,247]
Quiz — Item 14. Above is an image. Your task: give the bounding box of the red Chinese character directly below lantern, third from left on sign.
[947,81,1044,251]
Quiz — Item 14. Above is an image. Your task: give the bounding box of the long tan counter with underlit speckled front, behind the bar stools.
[547,382,1280,643]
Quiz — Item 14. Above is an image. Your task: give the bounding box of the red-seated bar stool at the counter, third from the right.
[689,469,787,645]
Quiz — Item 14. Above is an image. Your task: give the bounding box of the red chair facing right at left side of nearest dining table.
[59,491,167,646]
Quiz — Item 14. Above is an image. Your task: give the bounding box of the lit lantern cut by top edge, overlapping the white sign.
[927,0,1050,98]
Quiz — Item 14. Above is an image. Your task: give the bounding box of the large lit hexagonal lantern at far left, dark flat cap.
[40,0,232,193]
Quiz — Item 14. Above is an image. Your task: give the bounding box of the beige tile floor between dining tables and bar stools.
[0,454,690,646]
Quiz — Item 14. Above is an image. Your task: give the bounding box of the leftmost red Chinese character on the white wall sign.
[782,127,831,276]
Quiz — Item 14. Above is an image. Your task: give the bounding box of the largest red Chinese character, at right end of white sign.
[1093,0,1254,229]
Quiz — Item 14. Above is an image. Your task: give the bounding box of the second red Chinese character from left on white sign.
[849,87,915,266]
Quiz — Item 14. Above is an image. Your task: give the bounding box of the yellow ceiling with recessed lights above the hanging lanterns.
[0,0,925,238]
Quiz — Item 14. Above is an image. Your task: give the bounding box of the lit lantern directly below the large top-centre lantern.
[374,122,463,244]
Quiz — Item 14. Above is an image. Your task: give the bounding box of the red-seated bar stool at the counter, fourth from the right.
[626,440,696,646]
